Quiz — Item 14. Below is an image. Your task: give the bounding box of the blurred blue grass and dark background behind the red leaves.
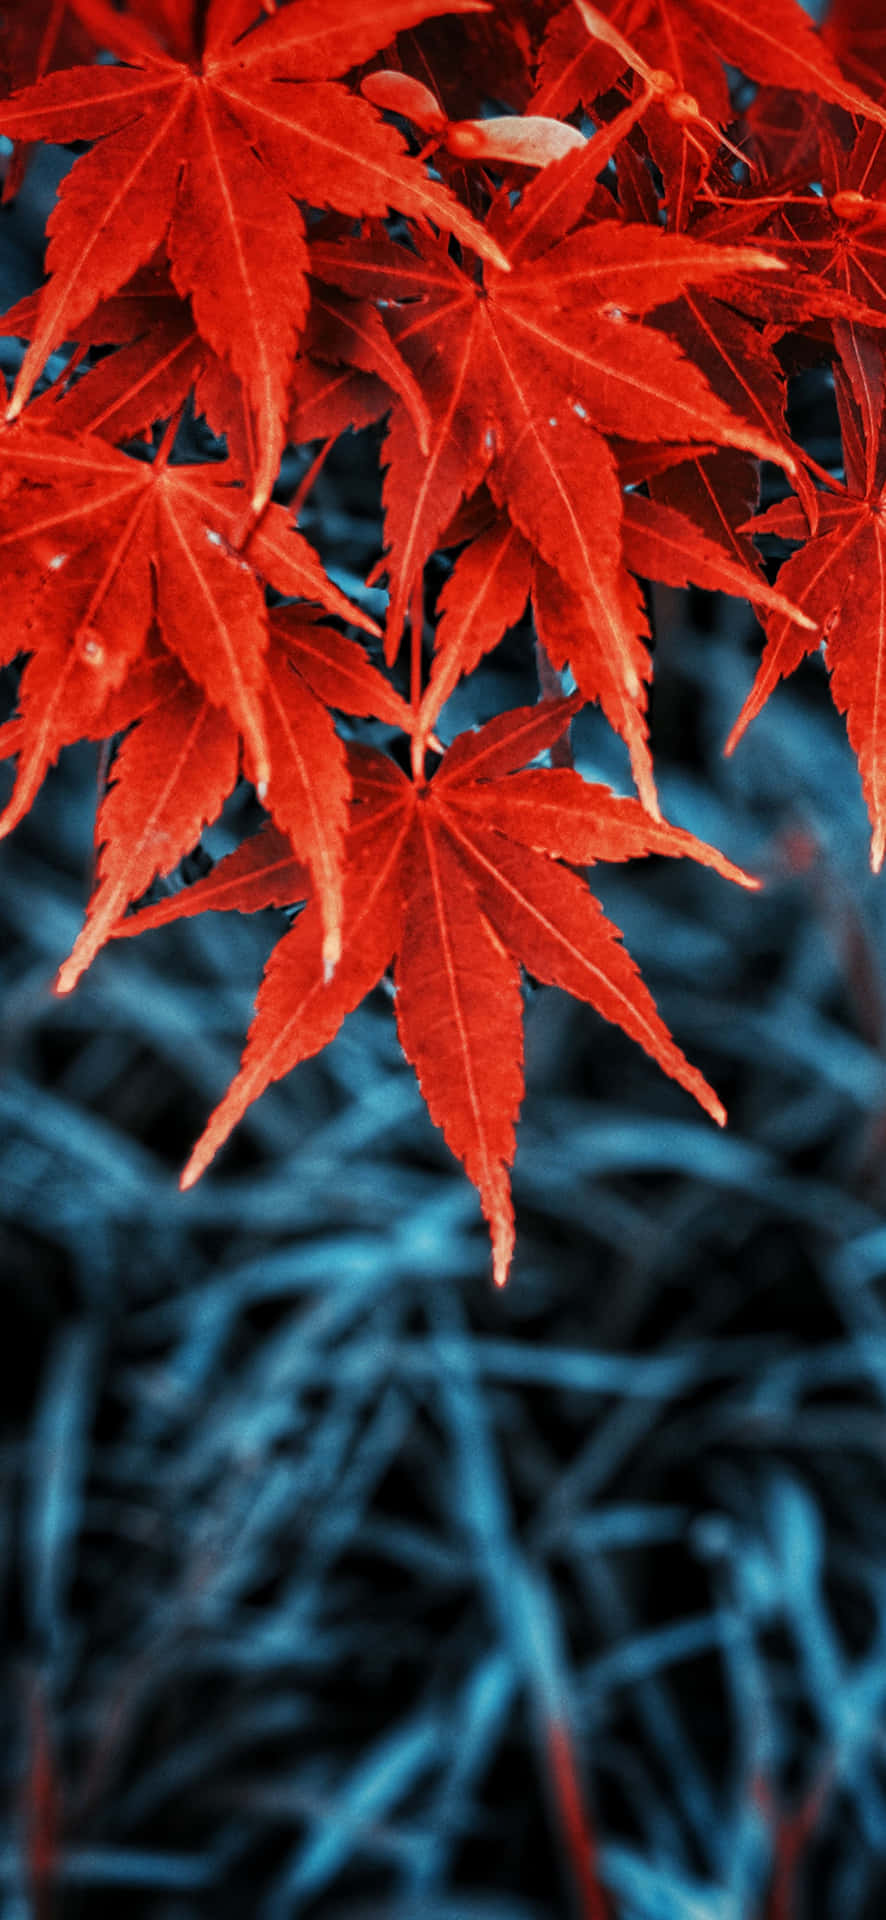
[0,135,886,1920]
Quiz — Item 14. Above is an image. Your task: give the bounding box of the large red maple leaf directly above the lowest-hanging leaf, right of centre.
[311,165,794,699]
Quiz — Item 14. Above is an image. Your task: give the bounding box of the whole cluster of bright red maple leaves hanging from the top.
[0,0,886,1281]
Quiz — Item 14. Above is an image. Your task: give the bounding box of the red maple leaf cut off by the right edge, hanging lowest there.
[726,326,886,872]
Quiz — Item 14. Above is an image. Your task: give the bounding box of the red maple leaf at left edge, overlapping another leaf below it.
[0,424,373,787]
